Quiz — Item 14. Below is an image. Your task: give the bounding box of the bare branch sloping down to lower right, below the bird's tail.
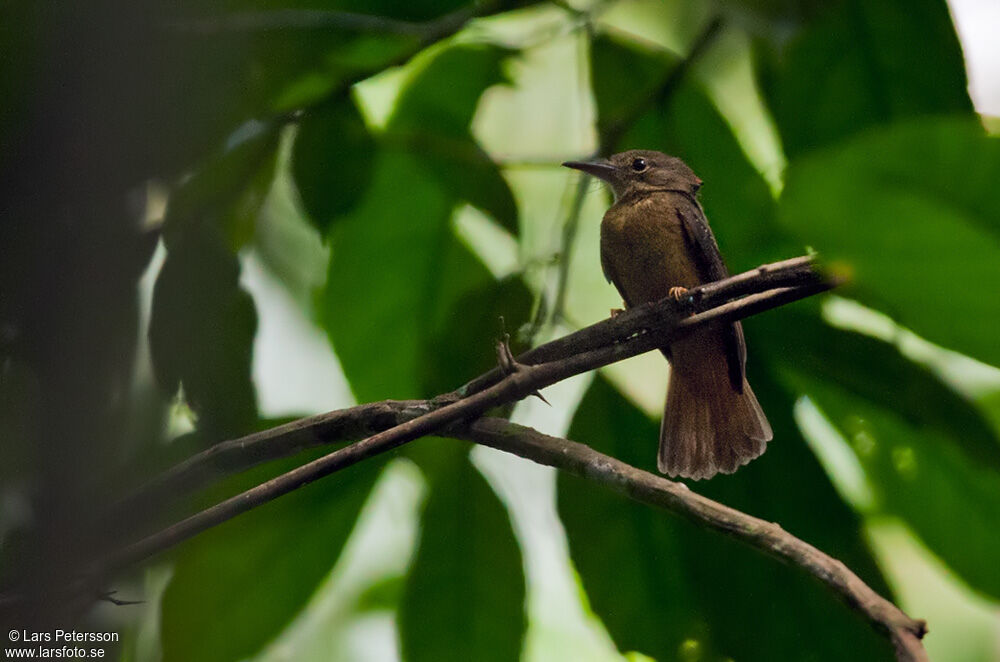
[458,418,928,662]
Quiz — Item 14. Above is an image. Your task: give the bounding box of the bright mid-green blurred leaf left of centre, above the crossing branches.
[321,153,492,401]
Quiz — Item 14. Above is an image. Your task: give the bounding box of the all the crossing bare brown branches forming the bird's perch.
[60,257,927,662]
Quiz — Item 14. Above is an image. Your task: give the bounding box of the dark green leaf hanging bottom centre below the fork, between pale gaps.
[399,452,526,662]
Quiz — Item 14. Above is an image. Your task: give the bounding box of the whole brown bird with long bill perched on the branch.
[563,150,773,480]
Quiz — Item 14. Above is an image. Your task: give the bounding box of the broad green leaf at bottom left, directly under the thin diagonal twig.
[161,453,384,662]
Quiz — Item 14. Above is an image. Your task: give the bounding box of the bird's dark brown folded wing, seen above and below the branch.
[676,195,747,393]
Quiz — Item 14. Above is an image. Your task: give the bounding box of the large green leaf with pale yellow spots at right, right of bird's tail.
[761,316,1000,597]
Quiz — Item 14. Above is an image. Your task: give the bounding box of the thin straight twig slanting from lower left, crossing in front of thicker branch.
[93,256,832,578]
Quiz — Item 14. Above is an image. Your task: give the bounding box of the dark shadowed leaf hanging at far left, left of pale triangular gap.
[149,232,257,439]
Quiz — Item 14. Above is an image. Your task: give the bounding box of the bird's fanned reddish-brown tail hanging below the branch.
[657,361,773,480]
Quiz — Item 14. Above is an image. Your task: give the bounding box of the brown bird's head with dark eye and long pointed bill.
[563,149,701,200]
